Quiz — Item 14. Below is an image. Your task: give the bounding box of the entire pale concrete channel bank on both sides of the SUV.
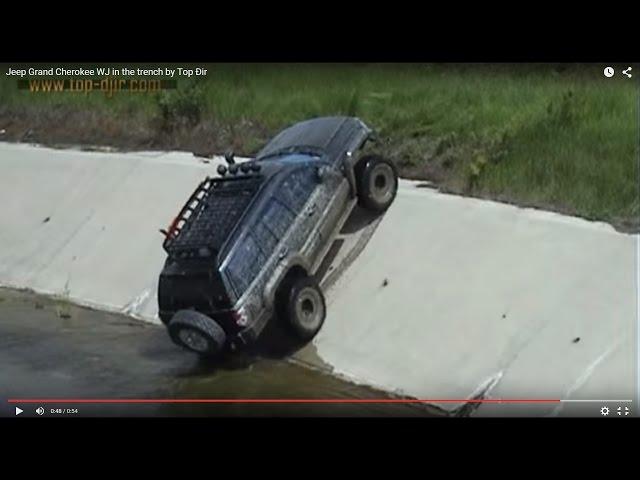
[0,144,638,416]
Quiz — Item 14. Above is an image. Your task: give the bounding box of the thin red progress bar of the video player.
[7,398,560,404]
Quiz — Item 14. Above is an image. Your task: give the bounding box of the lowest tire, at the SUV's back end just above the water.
[167,310,227,357]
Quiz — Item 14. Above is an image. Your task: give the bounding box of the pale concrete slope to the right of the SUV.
[316,182,637,414]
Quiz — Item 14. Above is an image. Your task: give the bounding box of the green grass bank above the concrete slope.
[0,64,640,230]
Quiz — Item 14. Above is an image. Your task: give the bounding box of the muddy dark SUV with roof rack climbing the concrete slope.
[158,117,398,356]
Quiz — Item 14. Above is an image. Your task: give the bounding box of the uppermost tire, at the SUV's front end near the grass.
[355,155,398,213]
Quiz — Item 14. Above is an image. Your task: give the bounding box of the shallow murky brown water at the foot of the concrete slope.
[0,289,437,416]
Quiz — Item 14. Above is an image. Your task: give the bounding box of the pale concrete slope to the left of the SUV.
[0,144,215,322]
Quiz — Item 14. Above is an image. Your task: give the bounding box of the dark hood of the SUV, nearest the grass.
[256,116,371,160]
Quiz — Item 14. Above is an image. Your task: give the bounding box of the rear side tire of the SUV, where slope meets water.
[278,276,327,342]
